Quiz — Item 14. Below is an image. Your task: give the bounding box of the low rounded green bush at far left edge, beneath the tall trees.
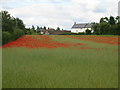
[2,31,12,45]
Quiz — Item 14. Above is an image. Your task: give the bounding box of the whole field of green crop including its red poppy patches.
[2,35,120,88]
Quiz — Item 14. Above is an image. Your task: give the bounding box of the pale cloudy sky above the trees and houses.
[0,0,119,30]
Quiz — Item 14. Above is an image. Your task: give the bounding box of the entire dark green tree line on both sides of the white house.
[0,11,120,44]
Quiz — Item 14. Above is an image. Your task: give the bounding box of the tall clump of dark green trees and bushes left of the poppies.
[0,11,27,44]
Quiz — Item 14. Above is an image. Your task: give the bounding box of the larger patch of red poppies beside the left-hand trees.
[2,35,69,48]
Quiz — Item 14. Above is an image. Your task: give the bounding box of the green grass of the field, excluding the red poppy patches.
[2,36,118,88]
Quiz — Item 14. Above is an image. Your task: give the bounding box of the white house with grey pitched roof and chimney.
[71,22,93,33]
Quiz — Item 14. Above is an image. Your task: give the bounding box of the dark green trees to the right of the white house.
[93,16,120,35]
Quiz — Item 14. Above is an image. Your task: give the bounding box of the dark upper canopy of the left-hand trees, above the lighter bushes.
[0,11,26,33]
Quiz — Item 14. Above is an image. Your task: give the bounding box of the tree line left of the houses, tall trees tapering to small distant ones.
[0,11,60,45]
